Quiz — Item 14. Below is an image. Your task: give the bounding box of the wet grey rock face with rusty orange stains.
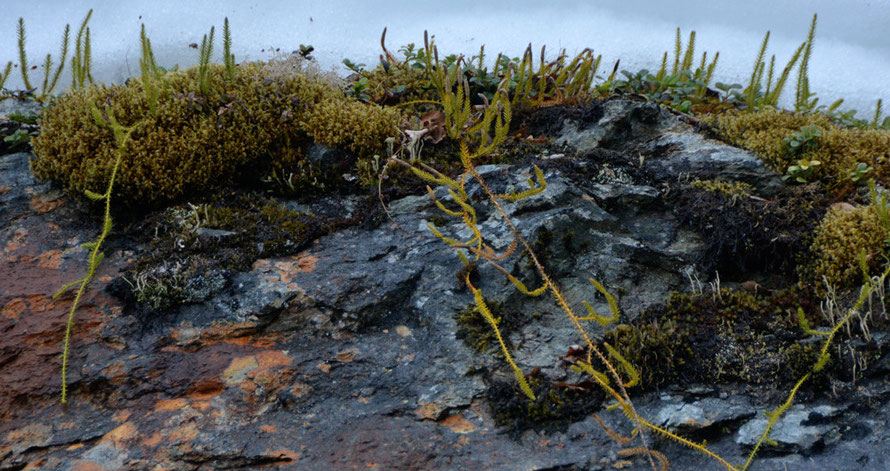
[0,97,890,470]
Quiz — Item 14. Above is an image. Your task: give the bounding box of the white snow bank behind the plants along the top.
[0,0,890,117]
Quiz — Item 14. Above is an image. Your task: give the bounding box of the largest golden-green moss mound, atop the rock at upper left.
[32,63,400,206]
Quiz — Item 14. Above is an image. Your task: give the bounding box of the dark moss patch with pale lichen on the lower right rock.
[603,288,887,392]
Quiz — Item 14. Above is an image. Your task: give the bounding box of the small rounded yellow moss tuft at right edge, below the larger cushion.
[801,206,886,293]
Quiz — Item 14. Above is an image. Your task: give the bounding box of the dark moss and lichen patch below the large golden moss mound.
[118,195,338,311]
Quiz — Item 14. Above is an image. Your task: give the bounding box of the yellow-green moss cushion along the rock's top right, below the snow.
[703,109,890,181]
